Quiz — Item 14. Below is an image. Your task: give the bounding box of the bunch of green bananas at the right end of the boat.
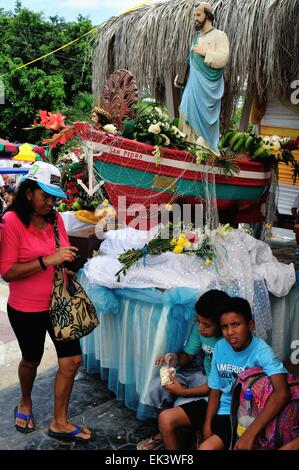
[218,130,269,159]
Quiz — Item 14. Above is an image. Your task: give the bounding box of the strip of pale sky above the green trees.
[0,0,150,25]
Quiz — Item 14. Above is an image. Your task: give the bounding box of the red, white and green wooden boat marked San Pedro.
[74,123,272,228]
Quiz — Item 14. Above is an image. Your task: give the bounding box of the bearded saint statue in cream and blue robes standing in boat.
[180,2,229,155]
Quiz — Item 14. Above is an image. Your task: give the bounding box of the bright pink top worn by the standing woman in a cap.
[0,211,70,312]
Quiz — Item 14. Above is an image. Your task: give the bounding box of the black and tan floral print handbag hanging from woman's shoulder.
[50,220,100,341]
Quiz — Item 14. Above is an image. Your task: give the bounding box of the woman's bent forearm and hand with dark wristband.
[2,246,78,282]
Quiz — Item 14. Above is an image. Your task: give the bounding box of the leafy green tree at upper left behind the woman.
[0,6,92,143]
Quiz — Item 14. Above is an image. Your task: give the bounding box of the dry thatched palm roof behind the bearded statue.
[93,0,299,121]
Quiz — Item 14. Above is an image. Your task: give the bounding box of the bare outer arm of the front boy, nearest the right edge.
[235,374,290,450]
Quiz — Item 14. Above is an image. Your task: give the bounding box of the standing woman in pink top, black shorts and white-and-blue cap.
[0,162,91,442]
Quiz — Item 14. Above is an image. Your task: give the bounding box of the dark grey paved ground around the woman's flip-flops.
[0,369,156,450]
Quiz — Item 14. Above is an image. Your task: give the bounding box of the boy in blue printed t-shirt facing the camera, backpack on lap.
[199,297,289,450]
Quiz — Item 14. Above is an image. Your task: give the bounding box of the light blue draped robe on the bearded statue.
[180,36,224,153]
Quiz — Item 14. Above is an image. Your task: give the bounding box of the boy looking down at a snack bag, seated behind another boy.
[137,289,230,450]
